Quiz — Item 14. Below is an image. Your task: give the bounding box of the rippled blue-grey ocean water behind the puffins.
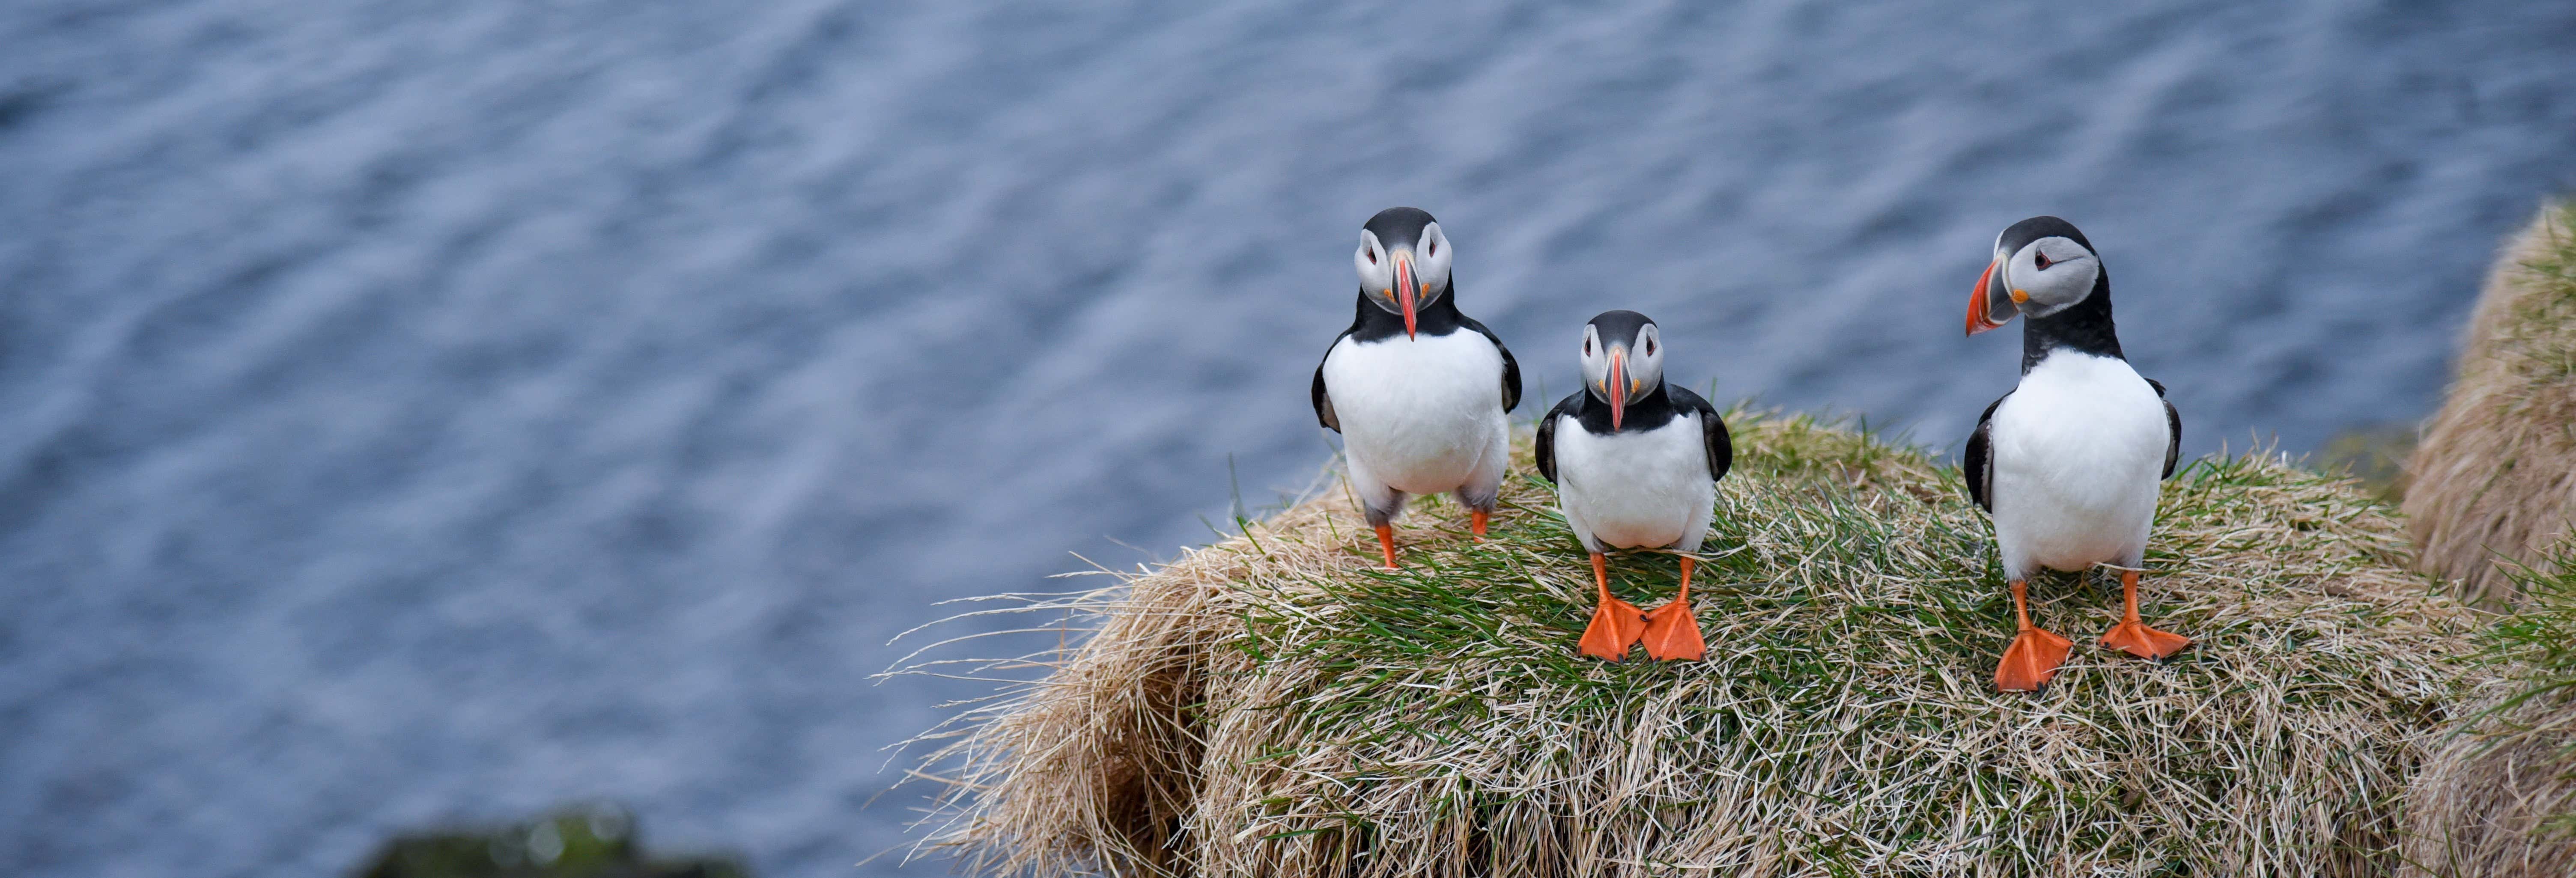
[0,0,2576,878]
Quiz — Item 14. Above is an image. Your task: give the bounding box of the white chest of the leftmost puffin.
[1324,330,1509,494]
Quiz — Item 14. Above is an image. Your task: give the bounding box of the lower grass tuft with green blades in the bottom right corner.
[2406,536,2576,878]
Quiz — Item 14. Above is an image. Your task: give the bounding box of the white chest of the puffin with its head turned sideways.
[1989,350,2171,574]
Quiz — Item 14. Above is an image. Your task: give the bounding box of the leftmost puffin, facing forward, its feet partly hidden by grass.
[1314,206,1520,569]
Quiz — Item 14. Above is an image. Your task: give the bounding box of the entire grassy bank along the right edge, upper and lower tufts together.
[2406,198,2576,878]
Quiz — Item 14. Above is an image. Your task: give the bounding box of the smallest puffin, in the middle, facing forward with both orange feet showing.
[1535,312,1736,662]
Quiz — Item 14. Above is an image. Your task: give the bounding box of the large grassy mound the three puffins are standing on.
[925,414,2475,875]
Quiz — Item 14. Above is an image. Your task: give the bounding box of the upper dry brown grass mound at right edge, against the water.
[2406,203,2576,602]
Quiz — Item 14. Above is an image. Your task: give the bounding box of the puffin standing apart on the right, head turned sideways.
[1965,216,2192,693]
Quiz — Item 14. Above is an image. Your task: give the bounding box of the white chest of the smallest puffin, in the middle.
[1556,414,1718,551]
